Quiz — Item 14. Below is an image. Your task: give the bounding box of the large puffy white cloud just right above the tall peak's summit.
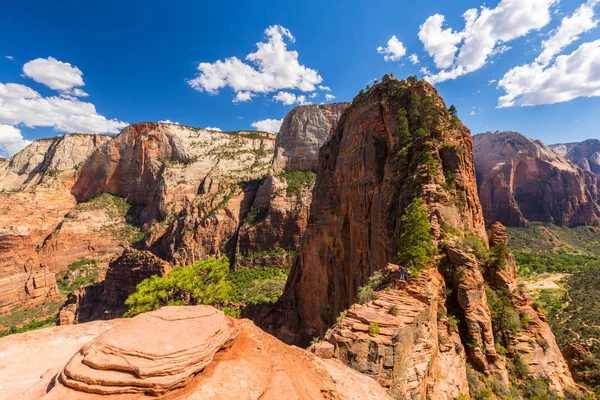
[419,0,559,84]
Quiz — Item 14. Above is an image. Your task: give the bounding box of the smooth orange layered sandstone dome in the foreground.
[21,306,391,400]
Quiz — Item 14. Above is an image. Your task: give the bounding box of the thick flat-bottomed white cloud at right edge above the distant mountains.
[498,40,600,107]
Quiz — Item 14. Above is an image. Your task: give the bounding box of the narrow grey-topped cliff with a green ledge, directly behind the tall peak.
[236,103,349,265]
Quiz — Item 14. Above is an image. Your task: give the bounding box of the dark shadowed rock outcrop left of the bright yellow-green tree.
[59,248,171,325]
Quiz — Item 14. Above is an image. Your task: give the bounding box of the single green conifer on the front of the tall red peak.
[398,198,436,270]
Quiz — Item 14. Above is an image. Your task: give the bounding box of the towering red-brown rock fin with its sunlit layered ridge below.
[259,76,574,398]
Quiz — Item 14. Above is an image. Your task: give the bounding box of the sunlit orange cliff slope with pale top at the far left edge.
[0,134,110,313]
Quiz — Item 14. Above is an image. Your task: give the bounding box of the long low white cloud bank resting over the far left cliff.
[0,83,127,133]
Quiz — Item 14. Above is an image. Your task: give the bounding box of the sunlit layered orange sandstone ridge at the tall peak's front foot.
[310,270,469,399]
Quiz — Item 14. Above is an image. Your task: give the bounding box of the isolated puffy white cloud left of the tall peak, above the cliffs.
[188,25,323,101]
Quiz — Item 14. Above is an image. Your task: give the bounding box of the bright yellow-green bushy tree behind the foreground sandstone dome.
[125,257,232,317]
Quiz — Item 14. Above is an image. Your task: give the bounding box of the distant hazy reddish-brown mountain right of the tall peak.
[473,132,600,227]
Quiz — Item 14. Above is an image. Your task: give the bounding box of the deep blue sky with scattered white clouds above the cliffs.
[0,0,600,155]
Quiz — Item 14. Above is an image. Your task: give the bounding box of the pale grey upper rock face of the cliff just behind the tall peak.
[273,103,350,172]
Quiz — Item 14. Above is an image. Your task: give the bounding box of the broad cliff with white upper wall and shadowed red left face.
[72,123,274,263]
